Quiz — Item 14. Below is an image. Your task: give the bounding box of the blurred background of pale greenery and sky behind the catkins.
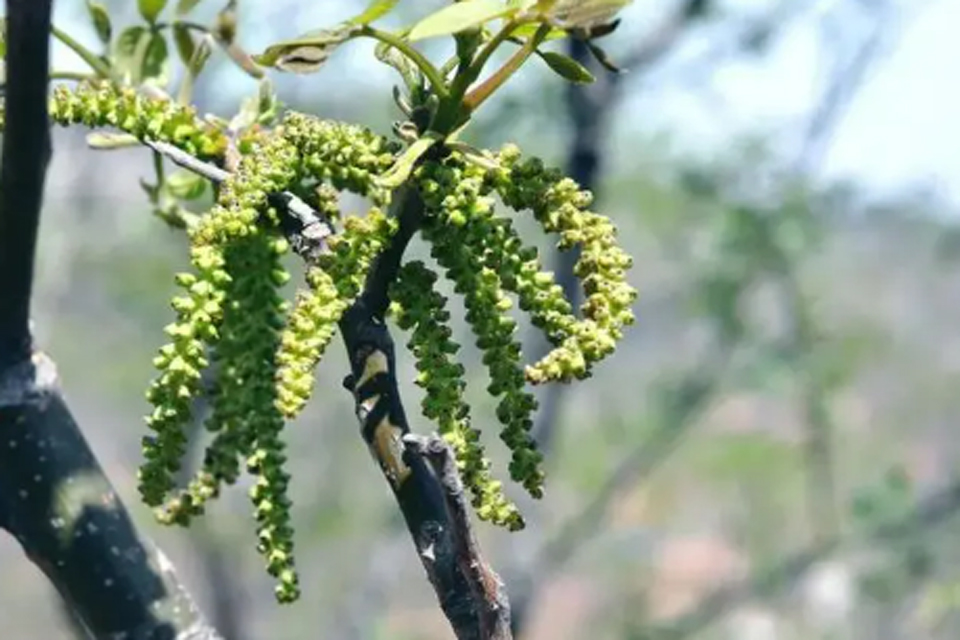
[0,0,960,640]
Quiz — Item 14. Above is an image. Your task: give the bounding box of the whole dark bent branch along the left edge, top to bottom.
[0,6,220,640]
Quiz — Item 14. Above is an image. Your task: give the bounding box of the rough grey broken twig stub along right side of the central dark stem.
[403,433,513,640]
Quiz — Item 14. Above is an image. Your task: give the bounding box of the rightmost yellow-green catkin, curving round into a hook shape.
[487,145,637,384]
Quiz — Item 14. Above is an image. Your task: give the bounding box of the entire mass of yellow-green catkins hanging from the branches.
[28,83,636,602]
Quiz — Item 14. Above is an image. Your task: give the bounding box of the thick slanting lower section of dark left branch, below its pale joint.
[0,352,220,640]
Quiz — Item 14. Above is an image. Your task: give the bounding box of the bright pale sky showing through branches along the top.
[48,0,960,205]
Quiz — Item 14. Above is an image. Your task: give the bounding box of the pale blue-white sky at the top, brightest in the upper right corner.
[48,0,960,204]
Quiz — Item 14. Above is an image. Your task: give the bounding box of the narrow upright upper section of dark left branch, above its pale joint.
[0,0,53,366]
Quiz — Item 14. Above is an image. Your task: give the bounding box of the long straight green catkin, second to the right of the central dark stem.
[416,159,544,498]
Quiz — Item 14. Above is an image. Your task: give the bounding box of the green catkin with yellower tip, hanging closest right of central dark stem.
[391,261,524,531]
